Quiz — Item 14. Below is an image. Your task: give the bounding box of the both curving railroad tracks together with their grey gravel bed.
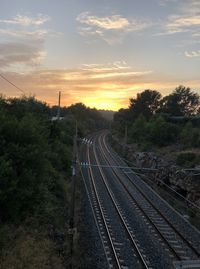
[81,133,200,269]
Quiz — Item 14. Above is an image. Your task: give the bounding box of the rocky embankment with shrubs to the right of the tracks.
[110,133,200,207]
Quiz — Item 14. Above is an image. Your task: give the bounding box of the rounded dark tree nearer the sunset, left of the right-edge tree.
[129,90,161,119]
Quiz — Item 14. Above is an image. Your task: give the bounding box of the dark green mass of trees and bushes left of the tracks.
[0,96,107,269]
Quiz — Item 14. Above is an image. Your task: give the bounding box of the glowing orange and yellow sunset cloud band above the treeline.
[0,62,200,110]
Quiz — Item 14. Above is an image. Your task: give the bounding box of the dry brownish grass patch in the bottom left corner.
[0,226,65,269]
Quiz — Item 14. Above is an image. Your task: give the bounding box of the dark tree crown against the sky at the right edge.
[160,86,200,116]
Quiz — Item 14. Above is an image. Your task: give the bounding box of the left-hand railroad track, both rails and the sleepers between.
[81,135,152,269]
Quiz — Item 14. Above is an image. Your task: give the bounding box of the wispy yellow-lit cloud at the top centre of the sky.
[77,12,152,44]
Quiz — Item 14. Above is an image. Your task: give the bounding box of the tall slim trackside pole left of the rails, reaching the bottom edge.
[69,120,78,269]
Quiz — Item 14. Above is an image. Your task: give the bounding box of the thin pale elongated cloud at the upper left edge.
[0,14,50,26]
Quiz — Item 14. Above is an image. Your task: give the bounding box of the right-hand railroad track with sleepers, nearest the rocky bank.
[98,134,200,260]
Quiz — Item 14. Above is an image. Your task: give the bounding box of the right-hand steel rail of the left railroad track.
[90,135,151,269]
